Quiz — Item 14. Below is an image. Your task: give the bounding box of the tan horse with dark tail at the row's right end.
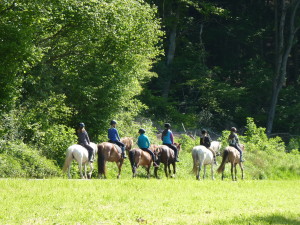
[217,145,244,181]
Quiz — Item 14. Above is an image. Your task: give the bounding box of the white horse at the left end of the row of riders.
[63,142,98,179]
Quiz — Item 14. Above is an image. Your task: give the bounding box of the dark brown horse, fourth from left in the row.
[152,143,181,178]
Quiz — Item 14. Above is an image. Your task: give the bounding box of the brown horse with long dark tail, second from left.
[98,142,124,179]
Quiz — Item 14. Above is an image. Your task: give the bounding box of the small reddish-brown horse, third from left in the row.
[129,148,152,178]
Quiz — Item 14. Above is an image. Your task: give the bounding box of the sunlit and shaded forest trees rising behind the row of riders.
[0,0,300,176]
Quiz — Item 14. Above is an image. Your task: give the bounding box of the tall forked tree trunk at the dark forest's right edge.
[267,0,300,136]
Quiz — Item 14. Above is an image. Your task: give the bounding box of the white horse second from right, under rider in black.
[192,145,215,180]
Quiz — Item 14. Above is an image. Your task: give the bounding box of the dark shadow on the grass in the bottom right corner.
[215,214,300,225]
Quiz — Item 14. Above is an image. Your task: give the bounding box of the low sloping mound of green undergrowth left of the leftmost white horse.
[0,142,61,178]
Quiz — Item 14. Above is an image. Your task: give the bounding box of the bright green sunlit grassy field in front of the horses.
[0,178,300,225]
